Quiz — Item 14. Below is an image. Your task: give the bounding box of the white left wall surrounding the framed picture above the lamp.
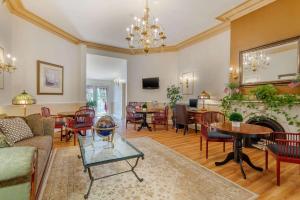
[0,5,86,114]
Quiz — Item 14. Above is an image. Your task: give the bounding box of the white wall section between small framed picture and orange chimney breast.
[178,31,230,100]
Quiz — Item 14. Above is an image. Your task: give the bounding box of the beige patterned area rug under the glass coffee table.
[42,137,257,200]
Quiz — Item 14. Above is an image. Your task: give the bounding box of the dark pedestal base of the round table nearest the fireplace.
[215,137,263,179]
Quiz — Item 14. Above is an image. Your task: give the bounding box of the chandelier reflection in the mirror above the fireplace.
[243,51,270,72]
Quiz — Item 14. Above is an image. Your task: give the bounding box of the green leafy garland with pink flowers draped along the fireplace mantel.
[221,83,300,132]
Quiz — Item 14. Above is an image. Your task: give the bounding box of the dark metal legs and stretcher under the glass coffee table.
[84,157,144,199]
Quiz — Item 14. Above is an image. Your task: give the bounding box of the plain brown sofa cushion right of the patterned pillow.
[25,113,44,136]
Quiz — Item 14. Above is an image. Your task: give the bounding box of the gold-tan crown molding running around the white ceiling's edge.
[5,0,276,55]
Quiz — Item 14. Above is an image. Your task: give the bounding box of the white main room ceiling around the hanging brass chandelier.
[22,0,245,47]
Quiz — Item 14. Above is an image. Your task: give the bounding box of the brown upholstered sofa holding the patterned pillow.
[0,114,55,196]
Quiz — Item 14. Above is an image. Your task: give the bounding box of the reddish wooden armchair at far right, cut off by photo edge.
[265,132,300,186]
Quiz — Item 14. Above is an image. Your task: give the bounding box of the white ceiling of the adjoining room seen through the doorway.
[86,54,127,80]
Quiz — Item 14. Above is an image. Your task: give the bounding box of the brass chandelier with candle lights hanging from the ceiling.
[126,0,167,53]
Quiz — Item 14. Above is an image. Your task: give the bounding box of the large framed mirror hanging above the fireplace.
[240,37,300,86]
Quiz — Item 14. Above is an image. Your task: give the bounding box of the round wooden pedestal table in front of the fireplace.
[211,122,273,179]
